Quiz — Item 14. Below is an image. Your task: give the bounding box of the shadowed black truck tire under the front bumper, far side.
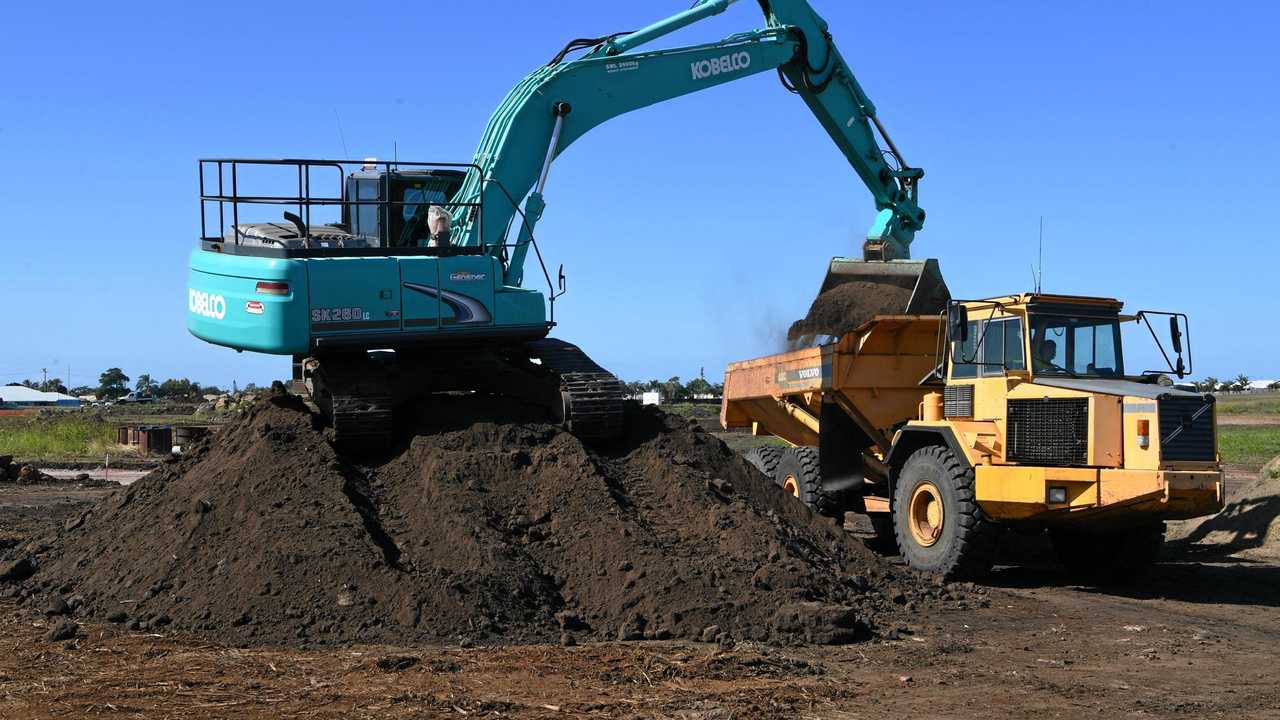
[1050,523,1165,583]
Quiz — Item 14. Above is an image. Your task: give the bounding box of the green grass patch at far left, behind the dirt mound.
[0,413,118,460]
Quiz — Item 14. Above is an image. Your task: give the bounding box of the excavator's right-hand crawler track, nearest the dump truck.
[529,338,627,441]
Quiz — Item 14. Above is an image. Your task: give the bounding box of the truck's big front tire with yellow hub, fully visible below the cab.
[892,445,997,580]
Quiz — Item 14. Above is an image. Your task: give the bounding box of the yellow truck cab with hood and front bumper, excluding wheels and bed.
[909,293,1222,527]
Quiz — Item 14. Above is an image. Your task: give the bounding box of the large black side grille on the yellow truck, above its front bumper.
[1006,397,1089,465]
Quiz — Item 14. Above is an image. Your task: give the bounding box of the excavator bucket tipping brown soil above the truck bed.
[787,258,951,347]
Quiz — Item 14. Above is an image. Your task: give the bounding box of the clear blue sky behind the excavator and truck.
[0,0,1280,392]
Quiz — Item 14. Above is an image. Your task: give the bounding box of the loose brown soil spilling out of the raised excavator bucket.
[787,277,916,347]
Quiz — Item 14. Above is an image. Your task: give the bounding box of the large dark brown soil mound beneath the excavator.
[18,396,956,644]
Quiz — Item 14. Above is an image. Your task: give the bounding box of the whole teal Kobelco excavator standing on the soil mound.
[187,0,950,452]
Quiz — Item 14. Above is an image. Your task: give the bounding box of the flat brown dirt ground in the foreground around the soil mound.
[0,461,1280,719]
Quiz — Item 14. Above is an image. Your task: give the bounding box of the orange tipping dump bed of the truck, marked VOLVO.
[721,315,941,451]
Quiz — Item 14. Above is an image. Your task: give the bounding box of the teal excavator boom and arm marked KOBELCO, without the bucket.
[453,0,924,286]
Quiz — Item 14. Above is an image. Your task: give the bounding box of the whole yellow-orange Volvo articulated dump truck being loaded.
[721,293,1224,579]
